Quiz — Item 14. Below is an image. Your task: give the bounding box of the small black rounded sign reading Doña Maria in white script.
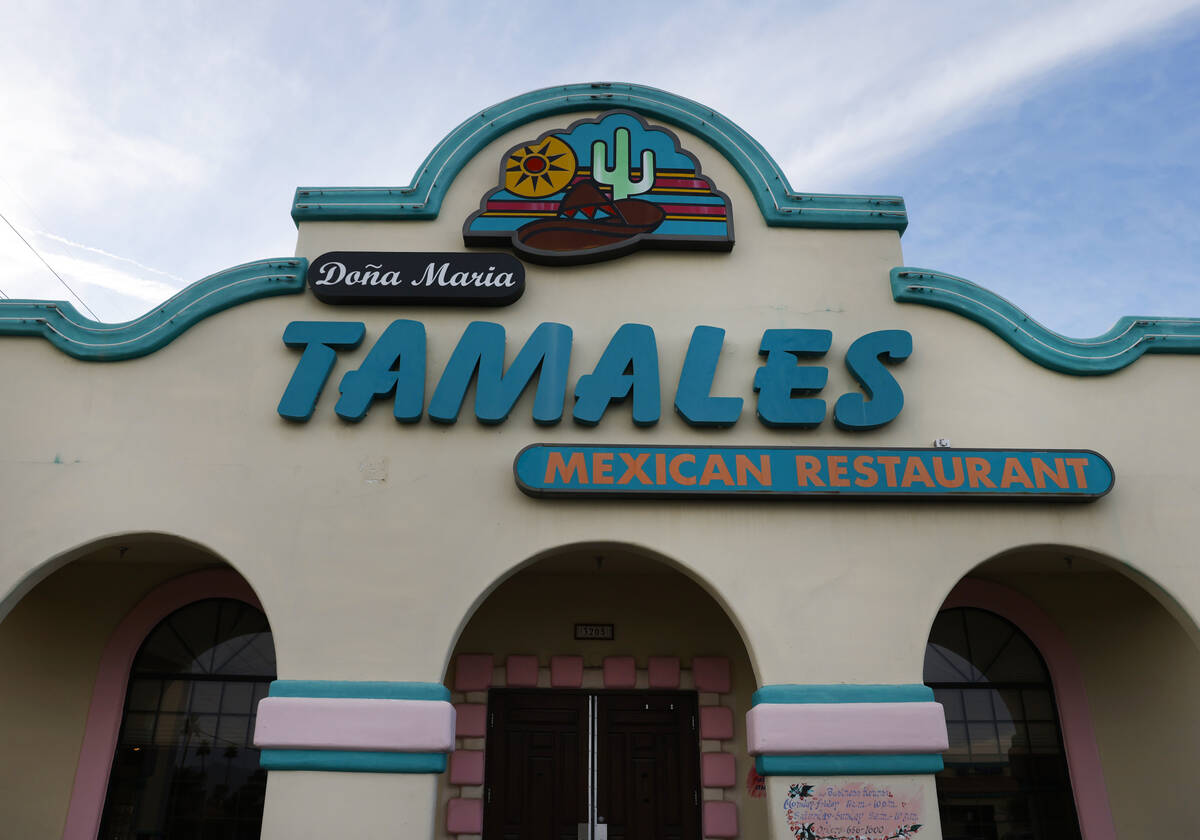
[308,251,524,306]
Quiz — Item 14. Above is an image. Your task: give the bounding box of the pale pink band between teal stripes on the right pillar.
[746,703,949,755]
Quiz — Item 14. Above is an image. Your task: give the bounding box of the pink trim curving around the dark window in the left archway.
[62,569,263,840]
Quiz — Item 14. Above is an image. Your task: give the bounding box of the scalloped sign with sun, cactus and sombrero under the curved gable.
[462,110,733,264]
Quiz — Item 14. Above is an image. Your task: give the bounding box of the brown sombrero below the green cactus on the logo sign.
[516,179,666,253]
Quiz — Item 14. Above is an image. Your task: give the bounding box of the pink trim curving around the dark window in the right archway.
[942,577,1117,840]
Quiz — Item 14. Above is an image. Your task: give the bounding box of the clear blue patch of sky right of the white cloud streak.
[883,20,1200,335]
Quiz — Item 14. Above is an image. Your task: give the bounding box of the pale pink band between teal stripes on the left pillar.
[254,697,455,752]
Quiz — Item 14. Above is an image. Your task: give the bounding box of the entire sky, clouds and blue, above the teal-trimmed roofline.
[0,0,1200,336]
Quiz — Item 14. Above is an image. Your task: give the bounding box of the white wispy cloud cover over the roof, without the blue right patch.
[0,0,1200,317]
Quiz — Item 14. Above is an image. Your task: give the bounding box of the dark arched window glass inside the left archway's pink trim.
[100,599,275,840]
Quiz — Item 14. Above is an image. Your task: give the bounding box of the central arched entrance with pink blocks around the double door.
[439,545,767,840]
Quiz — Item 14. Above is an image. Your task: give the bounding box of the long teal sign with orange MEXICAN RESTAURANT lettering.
[512,444,1115,502]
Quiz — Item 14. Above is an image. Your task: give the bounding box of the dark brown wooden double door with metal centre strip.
[484,689,700,840]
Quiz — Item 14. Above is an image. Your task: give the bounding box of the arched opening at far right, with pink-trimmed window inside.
[925,546,1200,840]
